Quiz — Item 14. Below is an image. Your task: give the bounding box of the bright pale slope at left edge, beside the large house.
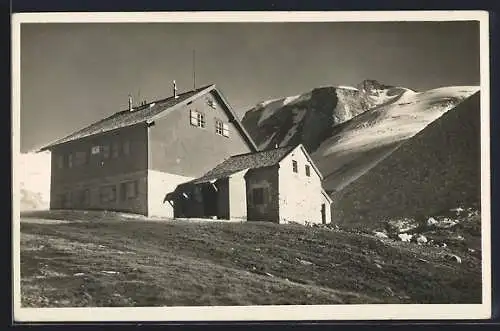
[16,152,51,210]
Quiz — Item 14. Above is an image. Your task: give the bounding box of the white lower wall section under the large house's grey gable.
[148,170,193,218]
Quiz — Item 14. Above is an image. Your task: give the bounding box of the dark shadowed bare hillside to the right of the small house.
[332,92,481,228]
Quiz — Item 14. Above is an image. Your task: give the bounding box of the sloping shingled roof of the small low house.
[192,146,297,184]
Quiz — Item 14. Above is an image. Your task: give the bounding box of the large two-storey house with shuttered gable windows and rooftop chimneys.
[42,85,257,217]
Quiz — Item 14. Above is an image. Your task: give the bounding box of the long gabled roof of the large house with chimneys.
[40,84,257,151]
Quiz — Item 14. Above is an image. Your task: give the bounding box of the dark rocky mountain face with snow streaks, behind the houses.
[242,80,409,154]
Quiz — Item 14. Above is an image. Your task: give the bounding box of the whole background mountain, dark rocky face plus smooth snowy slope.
[243,80,478,192]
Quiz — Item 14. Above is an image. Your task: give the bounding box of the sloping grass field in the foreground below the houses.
[21,212,481,307]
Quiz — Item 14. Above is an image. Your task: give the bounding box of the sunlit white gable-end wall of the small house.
[278,146,330,224]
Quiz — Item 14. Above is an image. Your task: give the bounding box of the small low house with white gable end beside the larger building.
[167,145,332,224]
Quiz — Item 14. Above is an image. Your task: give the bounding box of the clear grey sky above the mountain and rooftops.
[21,22,479,152]
